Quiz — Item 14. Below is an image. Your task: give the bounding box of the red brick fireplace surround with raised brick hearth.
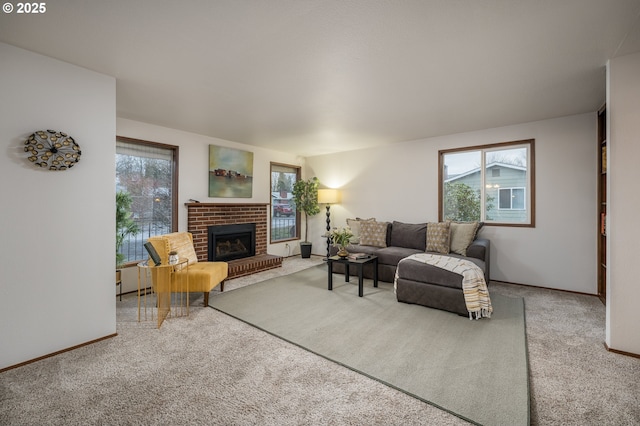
[185,203,282,278]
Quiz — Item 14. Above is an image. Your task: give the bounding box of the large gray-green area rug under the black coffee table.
[209,265,529,425]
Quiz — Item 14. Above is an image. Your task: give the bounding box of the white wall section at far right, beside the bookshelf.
[606,54,640,354]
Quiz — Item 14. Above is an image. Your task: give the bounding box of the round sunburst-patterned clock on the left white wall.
[24,130,82,170]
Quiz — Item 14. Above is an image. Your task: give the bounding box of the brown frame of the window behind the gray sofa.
[438,139,536,228]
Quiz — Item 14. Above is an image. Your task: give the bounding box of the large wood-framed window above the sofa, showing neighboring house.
[439,139,535,227]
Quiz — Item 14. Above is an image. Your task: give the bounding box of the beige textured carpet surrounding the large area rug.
[0,257,640,426]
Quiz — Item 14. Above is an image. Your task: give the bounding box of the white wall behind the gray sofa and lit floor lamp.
[307,113,597,294]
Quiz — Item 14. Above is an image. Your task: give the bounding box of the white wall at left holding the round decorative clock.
[0,43,116,368]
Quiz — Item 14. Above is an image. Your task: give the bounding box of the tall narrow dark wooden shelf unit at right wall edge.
[597,105,610,303]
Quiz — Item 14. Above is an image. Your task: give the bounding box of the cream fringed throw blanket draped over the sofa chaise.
[393,253,493,319]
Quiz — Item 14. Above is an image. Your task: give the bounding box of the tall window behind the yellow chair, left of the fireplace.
[116,137,178,262]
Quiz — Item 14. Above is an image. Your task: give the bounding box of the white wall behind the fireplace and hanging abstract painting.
[116,118,304,292]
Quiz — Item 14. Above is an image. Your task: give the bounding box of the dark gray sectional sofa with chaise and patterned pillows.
[332,219,490,316]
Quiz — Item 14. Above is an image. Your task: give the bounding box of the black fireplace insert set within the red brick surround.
[207,223,256,262]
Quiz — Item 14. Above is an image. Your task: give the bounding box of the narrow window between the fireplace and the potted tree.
[271,163,300,243]
